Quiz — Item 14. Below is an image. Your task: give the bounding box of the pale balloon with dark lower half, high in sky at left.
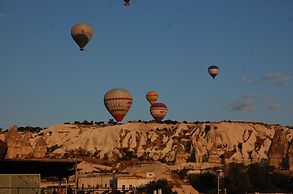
[71,23,93,51]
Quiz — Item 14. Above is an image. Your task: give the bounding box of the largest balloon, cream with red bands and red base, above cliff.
[104,88,132,122]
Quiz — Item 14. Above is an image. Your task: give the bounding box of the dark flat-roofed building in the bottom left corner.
[0,159,79,194]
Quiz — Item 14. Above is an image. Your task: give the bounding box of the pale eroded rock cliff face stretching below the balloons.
[2,122,293,170]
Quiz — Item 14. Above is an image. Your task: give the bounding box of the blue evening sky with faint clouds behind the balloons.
[0,0,293,129]
